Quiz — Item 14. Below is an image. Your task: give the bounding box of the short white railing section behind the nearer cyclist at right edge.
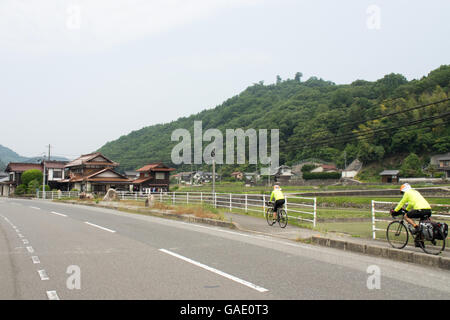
[372,200,450,239]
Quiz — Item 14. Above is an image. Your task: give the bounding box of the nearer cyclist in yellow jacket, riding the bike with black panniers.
[392,183,431,234]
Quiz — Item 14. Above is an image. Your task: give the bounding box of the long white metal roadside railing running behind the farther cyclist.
[37,191,317,227]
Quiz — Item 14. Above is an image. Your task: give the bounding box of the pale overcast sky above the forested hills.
[0,0,450,158]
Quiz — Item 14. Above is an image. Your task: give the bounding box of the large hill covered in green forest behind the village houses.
[99,65,450,170]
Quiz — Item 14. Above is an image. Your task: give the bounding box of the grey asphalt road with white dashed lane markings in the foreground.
[0,198,450,300]
